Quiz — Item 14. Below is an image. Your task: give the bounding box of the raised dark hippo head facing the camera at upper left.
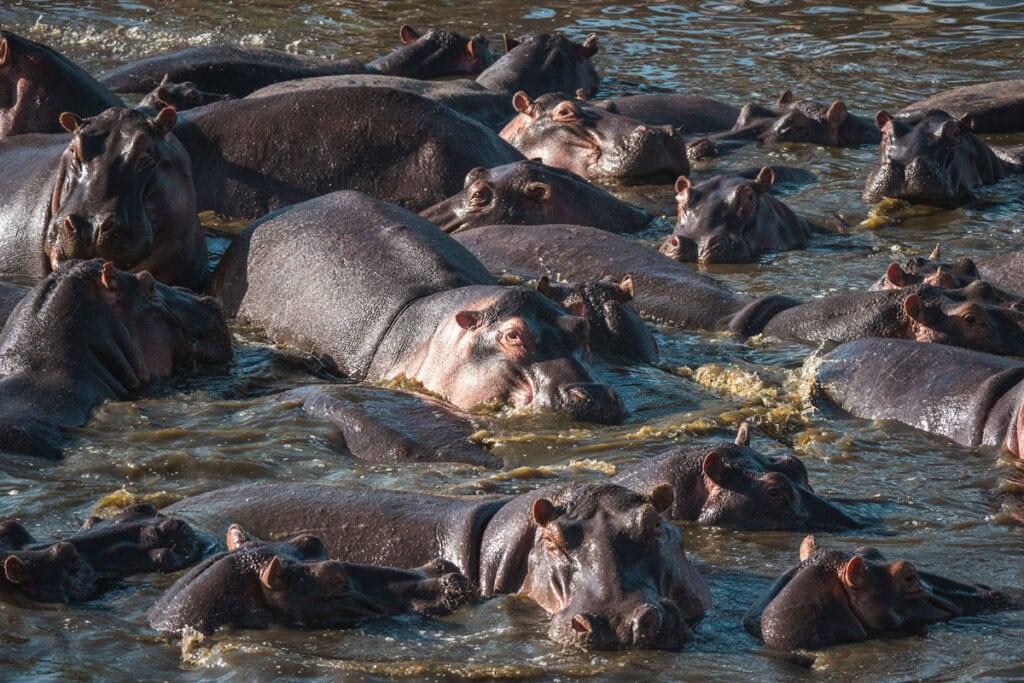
[44,108,197,270]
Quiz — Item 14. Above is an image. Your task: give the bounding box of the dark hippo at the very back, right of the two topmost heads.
[476,34,600,97]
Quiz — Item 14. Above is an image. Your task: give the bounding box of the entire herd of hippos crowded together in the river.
[0,27,1024,649]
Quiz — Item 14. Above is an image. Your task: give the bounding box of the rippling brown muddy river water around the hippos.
[0,0,1024,681]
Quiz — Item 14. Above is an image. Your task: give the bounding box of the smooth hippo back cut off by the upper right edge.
[897,79,1024,133]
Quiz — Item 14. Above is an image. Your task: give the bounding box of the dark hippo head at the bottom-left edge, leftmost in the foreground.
[0,543,97,602]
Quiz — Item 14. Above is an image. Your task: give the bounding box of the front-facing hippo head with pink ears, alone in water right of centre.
[659,166,778,263]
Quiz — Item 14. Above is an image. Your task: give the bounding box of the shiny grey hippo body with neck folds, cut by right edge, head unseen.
[817,339,1024,457]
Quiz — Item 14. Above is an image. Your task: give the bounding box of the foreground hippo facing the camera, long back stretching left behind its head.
[166,483,711,649]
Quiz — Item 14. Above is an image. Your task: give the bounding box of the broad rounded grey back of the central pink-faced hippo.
[211,191,494,378]
